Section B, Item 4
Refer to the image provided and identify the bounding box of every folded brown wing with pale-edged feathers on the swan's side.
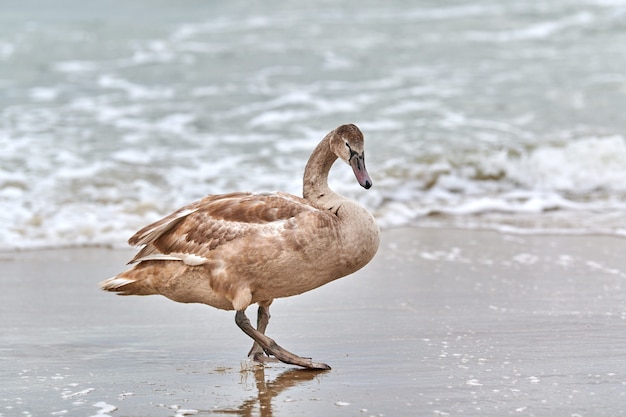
[128,192,336,265]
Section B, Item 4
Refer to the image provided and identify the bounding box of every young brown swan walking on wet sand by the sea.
[100,124,379,369]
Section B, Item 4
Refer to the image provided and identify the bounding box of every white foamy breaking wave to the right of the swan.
[368,135,626,234]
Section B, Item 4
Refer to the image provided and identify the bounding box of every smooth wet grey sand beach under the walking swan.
[0,229,626,417]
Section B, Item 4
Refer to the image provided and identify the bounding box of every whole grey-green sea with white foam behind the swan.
[0,0,626,250]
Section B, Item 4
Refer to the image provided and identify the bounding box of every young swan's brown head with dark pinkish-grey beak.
[330,124,372,189]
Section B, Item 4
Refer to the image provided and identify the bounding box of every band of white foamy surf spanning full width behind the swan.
[0,133,626,250]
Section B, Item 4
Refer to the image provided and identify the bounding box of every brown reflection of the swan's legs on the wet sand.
[212,365,328,417]
